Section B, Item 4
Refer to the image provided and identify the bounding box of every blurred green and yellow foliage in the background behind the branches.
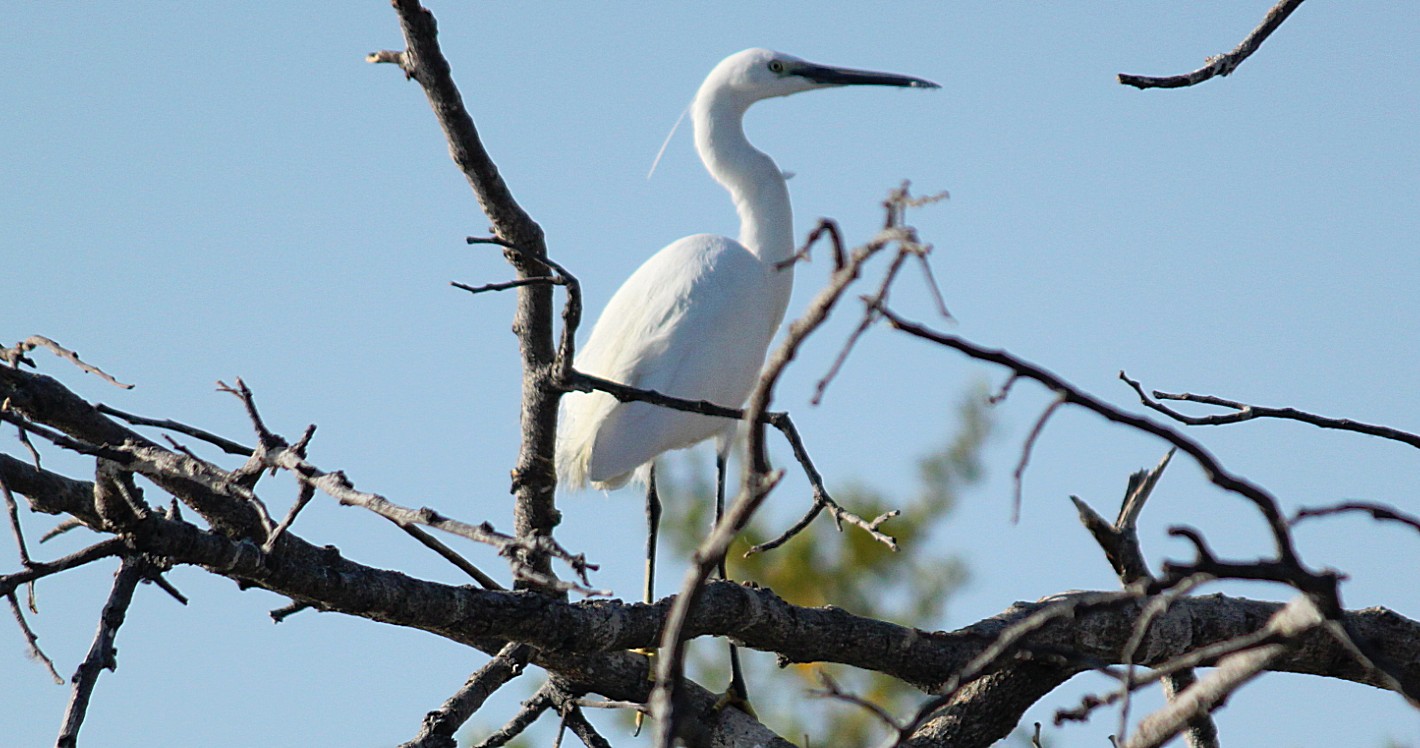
[657,392,991,745]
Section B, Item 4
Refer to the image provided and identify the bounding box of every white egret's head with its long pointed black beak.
[699,48,940,106]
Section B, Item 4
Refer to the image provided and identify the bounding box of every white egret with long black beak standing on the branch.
[557,50,937,704]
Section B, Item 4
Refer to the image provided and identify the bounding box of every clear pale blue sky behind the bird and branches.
[0,1,1420,748]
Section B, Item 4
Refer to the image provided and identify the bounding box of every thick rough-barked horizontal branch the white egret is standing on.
[0,451,1420,748]
